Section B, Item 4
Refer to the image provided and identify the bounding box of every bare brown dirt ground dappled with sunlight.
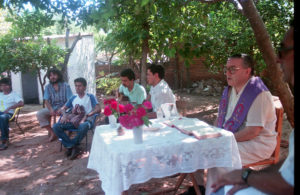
[0,93,291,195]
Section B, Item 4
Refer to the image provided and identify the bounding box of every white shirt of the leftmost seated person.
[0,91,23,114]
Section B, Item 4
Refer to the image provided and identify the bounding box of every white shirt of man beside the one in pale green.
[149,79,176,112]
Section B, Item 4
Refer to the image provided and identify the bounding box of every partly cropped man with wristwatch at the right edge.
[212,18,295,195]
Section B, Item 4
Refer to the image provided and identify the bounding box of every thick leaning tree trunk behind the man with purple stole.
[239,0,294,127]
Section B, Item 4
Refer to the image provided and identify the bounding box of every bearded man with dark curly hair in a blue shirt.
[36,68,73,142]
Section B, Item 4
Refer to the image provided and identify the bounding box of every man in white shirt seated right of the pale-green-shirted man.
[147,64,176,118]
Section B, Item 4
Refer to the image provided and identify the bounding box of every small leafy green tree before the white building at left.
[0,11,65,102]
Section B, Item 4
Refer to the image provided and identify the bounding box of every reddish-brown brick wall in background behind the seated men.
[96,58,226,89]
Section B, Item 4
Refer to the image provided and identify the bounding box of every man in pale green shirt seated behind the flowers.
[118,69,147,105]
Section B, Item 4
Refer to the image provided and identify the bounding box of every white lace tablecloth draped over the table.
[87,118,241,195]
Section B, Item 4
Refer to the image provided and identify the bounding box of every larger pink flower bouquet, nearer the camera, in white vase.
[119,101,152,129]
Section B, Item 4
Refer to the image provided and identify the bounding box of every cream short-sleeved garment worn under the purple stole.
[225,77,277,165]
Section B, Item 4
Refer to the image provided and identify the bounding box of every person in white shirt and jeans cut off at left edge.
[0,78,24,150]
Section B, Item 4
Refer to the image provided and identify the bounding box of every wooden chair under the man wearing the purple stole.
[243,96,283,168]
